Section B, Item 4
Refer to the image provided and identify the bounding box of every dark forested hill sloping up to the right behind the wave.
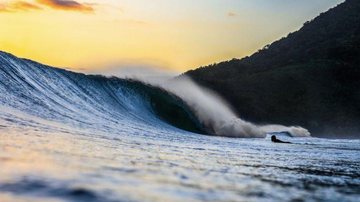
[185,0,360,138]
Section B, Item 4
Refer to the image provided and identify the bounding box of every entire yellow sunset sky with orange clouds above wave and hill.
[0,0,344,72]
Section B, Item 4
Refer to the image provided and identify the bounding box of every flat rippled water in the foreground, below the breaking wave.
[0,127,360,201]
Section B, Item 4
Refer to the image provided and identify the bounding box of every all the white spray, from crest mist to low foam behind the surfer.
[116,69,310,138]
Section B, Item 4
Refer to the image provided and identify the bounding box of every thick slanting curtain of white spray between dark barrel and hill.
[161,77,266,137]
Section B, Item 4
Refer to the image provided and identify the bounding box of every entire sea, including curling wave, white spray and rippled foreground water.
[0,52,360,201]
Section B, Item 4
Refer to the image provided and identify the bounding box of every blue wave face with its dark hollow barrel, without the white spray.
[0,53,205,136]
